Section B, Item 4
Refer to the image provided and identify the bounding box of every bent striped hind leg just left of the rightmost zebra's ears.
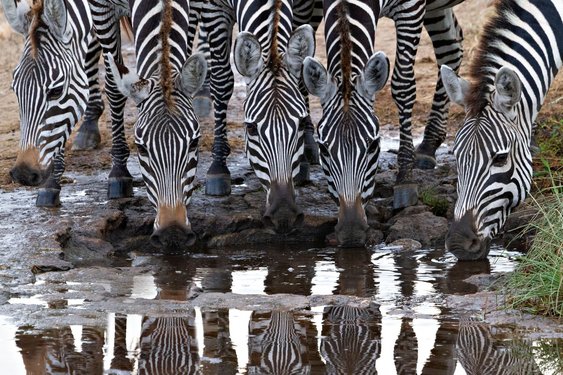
[415,8,463,169]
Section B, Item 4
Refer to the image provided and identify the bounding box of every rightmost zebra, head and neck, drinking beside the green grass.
[441,0,563,260]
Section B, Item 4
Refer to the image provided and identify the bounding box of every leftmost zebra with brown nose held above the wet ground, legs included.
[2,0,132,207]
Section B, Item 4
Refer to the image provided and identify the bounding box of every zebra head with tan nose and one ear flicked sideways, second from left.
[107,53,207,250]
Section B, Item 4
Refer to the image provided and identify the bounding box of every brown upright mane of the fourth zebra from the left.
[336,0,353,112]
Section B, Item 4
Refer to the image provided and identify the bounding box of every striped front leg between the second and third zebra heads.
[201,8,235,196]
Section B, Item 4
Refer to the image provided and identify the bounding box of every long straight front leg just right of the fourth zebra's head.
[391,0,425,209]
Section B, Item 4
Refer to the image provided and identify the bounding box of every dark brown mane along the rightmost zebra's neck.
[466,0,514,116]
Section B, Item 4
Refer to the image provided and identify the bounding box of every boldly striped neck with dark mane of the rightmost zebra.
[470,0,563,135]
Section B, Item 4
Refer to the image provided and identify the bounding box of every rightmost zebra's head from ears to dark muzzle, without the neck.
[441,66,532,260]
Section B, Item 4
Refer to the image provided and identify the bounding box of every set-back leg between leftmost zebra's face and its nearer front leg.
[72,38,104,150]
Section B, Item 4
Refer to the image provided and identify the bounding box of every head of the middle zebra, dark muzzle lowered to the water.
[234,25,315,233]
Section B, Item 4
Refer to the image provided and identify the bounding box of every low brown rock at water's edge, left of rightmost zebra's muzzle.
[385,210,448,247]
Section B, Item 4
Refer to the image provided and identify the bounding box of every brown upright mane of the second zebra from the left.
[160,0,174,108]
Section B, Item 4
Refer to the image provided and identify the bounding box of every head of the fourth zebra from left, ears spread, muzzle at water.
[303,52,389,246]
